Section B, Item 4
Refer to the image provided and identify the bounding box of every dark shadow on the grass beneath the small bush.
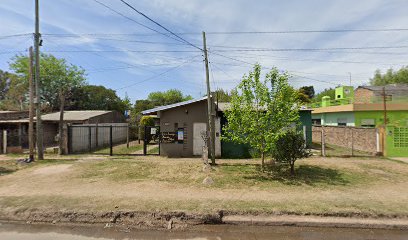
[245,165,350,186]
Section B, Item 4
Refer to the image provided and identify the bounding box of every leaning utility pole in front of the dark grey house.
[203,32,215,164]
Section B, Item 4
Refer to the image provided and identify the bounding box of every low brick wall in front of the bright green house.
[312,126,377,154]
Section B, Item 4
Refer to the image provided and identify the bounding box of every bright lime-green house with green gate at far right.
[311,84,408,157]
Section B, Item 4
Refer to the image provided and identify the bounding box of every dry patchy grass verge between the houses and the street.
[0,155,408,217]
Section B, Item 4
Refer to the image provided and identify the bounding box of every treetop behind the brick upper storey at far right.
[370,66,408,86]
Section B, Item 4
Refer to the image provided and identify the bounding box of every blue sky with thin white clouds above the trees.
[0,0,408,101]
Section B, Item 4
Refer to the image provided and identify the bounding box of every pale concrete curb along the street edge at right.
[222,215,408,230]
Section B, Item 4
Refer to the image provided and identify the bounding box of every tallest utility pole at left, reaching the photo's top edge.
[34,0,44,160]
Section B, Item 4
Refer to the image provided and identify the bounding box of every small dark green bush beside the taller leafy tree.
[271,130,310,175]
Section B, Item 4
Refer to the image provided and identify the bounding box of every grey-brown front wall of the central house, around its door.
[158,100,221,157]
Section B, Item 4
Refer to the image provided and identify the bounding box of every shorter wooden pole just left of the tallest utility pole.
[28,47,34,162]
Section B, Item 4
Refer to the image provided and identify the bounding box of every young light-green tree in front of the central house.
[224,64,299,166]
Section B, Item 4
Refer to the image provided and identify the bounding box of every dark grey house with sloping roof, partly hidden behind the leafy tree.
[142,97,312,158]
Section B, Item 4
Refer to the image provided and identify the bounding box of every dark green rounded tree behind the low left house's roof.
[70,85,129,113]
